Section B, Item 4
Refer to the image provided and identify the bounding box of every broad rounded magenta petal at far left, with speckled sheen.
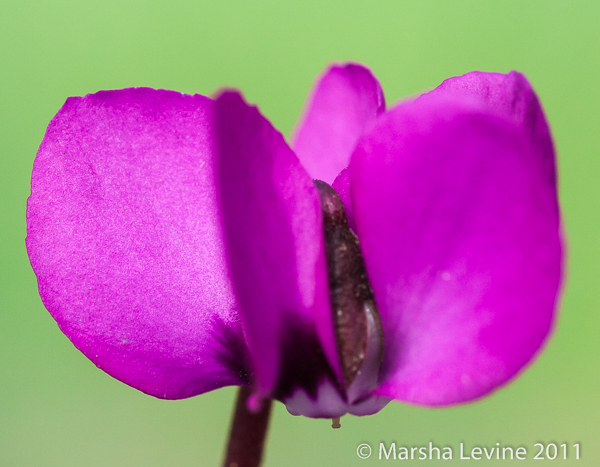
[27,88,249,399]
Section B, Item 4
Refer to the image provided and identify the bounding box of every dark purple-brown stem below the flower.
[223,386,273,467]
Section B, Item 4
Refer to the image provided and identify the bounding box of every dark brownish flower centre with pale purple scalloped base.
[280,180,389,420]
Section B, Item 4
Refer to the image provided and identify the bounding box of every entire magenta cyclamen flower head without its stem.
[27,64,562,417]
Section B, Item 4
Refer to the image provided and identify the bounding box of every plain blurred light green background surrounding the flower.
[0,0,600,466]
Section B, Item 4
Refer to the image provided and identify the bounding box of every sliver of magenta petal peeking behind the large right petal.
[423,71,556,187]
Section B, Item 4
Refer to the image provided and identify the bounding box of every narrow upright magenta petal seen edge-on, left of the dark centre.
[216,91,341,399]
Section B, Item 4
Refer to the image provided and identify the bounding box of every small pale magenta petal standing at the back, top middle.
[292,63,385,185]
